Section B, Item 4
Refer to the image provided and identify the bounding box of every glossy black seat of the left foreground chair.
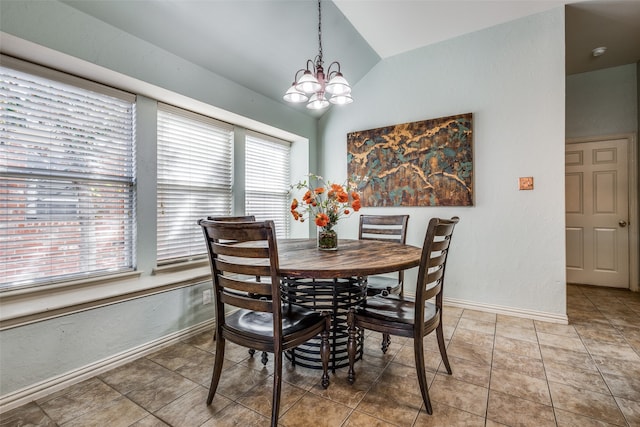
[225,305,323,338]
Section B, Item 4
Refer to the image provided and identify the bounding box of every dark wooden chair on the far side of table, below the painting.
[358,215,409,296]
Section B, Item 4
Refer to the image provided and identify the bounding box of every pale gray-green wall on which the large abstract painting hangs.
[320,8,566,320]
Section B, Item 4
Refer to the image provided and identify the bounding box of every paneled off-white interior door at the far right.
[565,139,629,288]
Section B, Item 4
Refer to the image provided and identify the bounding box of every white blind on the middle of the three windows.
[157,104,233,264]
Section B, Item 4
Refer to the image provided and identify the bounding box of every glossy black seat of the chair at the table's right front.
[356,295,436,325]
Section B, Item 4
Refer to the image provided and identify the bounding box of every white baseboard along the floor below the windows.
[0,319,215,414]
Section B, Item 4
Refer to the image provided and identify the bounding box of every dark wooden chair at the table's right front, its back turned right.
[347,216,459,414]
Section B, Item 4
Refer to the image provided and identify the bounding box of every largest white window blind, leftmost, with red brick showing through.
[0,56,135,289]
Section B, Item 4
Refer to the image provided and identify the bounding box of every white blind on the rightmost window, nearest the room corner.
[245,133,291,238]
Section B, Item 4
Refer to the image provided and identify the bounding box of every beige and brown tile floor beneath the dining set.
[0,286,640,427]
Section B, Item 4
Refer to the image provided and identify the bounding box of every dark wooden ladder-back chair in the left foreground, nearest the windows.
[198,219,330,426]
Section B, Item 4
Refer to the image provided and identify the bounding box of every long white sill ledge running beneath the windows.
[0,263,211,330]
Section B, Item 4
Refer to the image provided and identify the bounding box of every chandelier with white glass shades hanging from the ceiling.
[283,0,353,110]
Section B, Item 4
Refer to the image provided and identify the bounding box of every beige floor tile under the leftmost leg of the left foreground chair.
[154,387,233,427]
